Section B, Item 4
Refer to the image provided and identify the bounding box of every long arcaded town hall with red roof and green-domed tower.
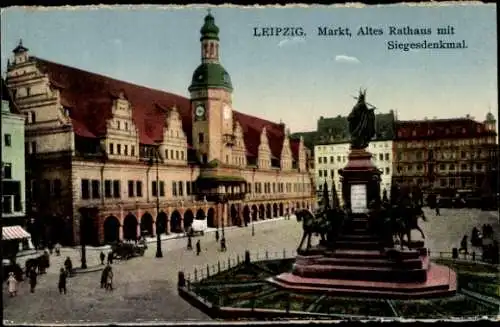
[6,14,315,244]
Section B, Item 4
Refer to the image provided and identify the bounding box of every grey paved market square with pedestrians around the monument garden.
[3,209,500,323]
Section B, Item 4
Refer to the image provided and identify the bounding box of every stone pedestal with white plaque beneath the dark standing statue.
[339,149,381,213]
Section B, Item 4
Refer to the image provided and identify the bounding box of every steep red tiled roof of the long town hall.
[33,57,298,159]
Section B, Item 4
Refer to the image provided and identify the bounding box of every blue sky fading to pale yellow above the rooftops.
[1,3,498,132]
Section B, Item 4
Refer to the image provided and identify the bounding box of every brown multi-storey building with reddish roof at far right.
[393,113,498,196]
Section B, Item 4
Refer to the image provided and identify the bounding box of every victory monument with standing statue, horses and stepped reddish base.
[268,91,456,299]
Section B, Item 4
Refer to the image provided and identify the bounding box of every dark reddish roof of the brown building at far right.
[396,118,496,139]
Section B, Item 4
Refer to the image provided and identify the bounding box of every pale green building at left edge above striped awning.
[1,79,26,226]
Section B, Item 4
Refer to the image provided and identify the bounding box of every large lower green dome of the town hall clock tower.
[189,63,233,91]
